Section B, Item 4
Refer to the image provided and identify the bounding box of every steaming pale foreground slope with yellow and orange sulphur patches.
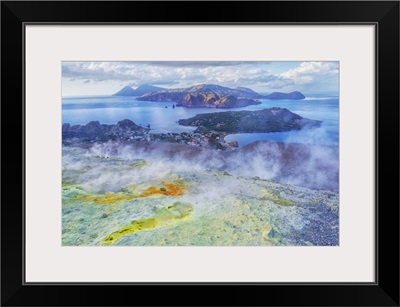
[62,141,339,246]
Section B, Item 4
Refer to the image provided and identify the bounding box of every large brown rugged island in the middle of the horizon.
[137,84,263,108]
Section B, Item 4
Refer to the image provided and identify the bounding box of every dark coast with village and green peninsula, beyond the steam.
[62,107,321,150]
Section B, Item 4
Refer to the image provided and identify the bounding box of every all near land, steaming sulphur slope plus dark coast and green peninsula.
[61,108,339,246]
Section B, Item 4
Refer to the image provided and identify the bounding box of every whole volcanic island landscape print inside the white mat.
[61,61,339,246]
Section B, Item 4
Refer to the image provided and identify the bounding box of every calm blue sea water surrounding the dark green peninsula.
[62,96,339,146]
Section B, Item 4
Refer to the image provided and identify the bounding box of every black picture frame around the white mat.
[1,1,399,306]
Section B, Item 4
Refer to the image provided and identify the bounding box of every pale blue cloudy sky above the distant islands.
[62,61,339,97]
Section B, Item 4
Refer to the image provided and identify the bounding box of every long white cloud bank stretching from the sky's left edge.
[63,62,271,86]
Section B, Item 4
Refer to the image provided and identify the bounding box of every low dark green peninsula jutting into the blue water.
[178,107,321,133]
